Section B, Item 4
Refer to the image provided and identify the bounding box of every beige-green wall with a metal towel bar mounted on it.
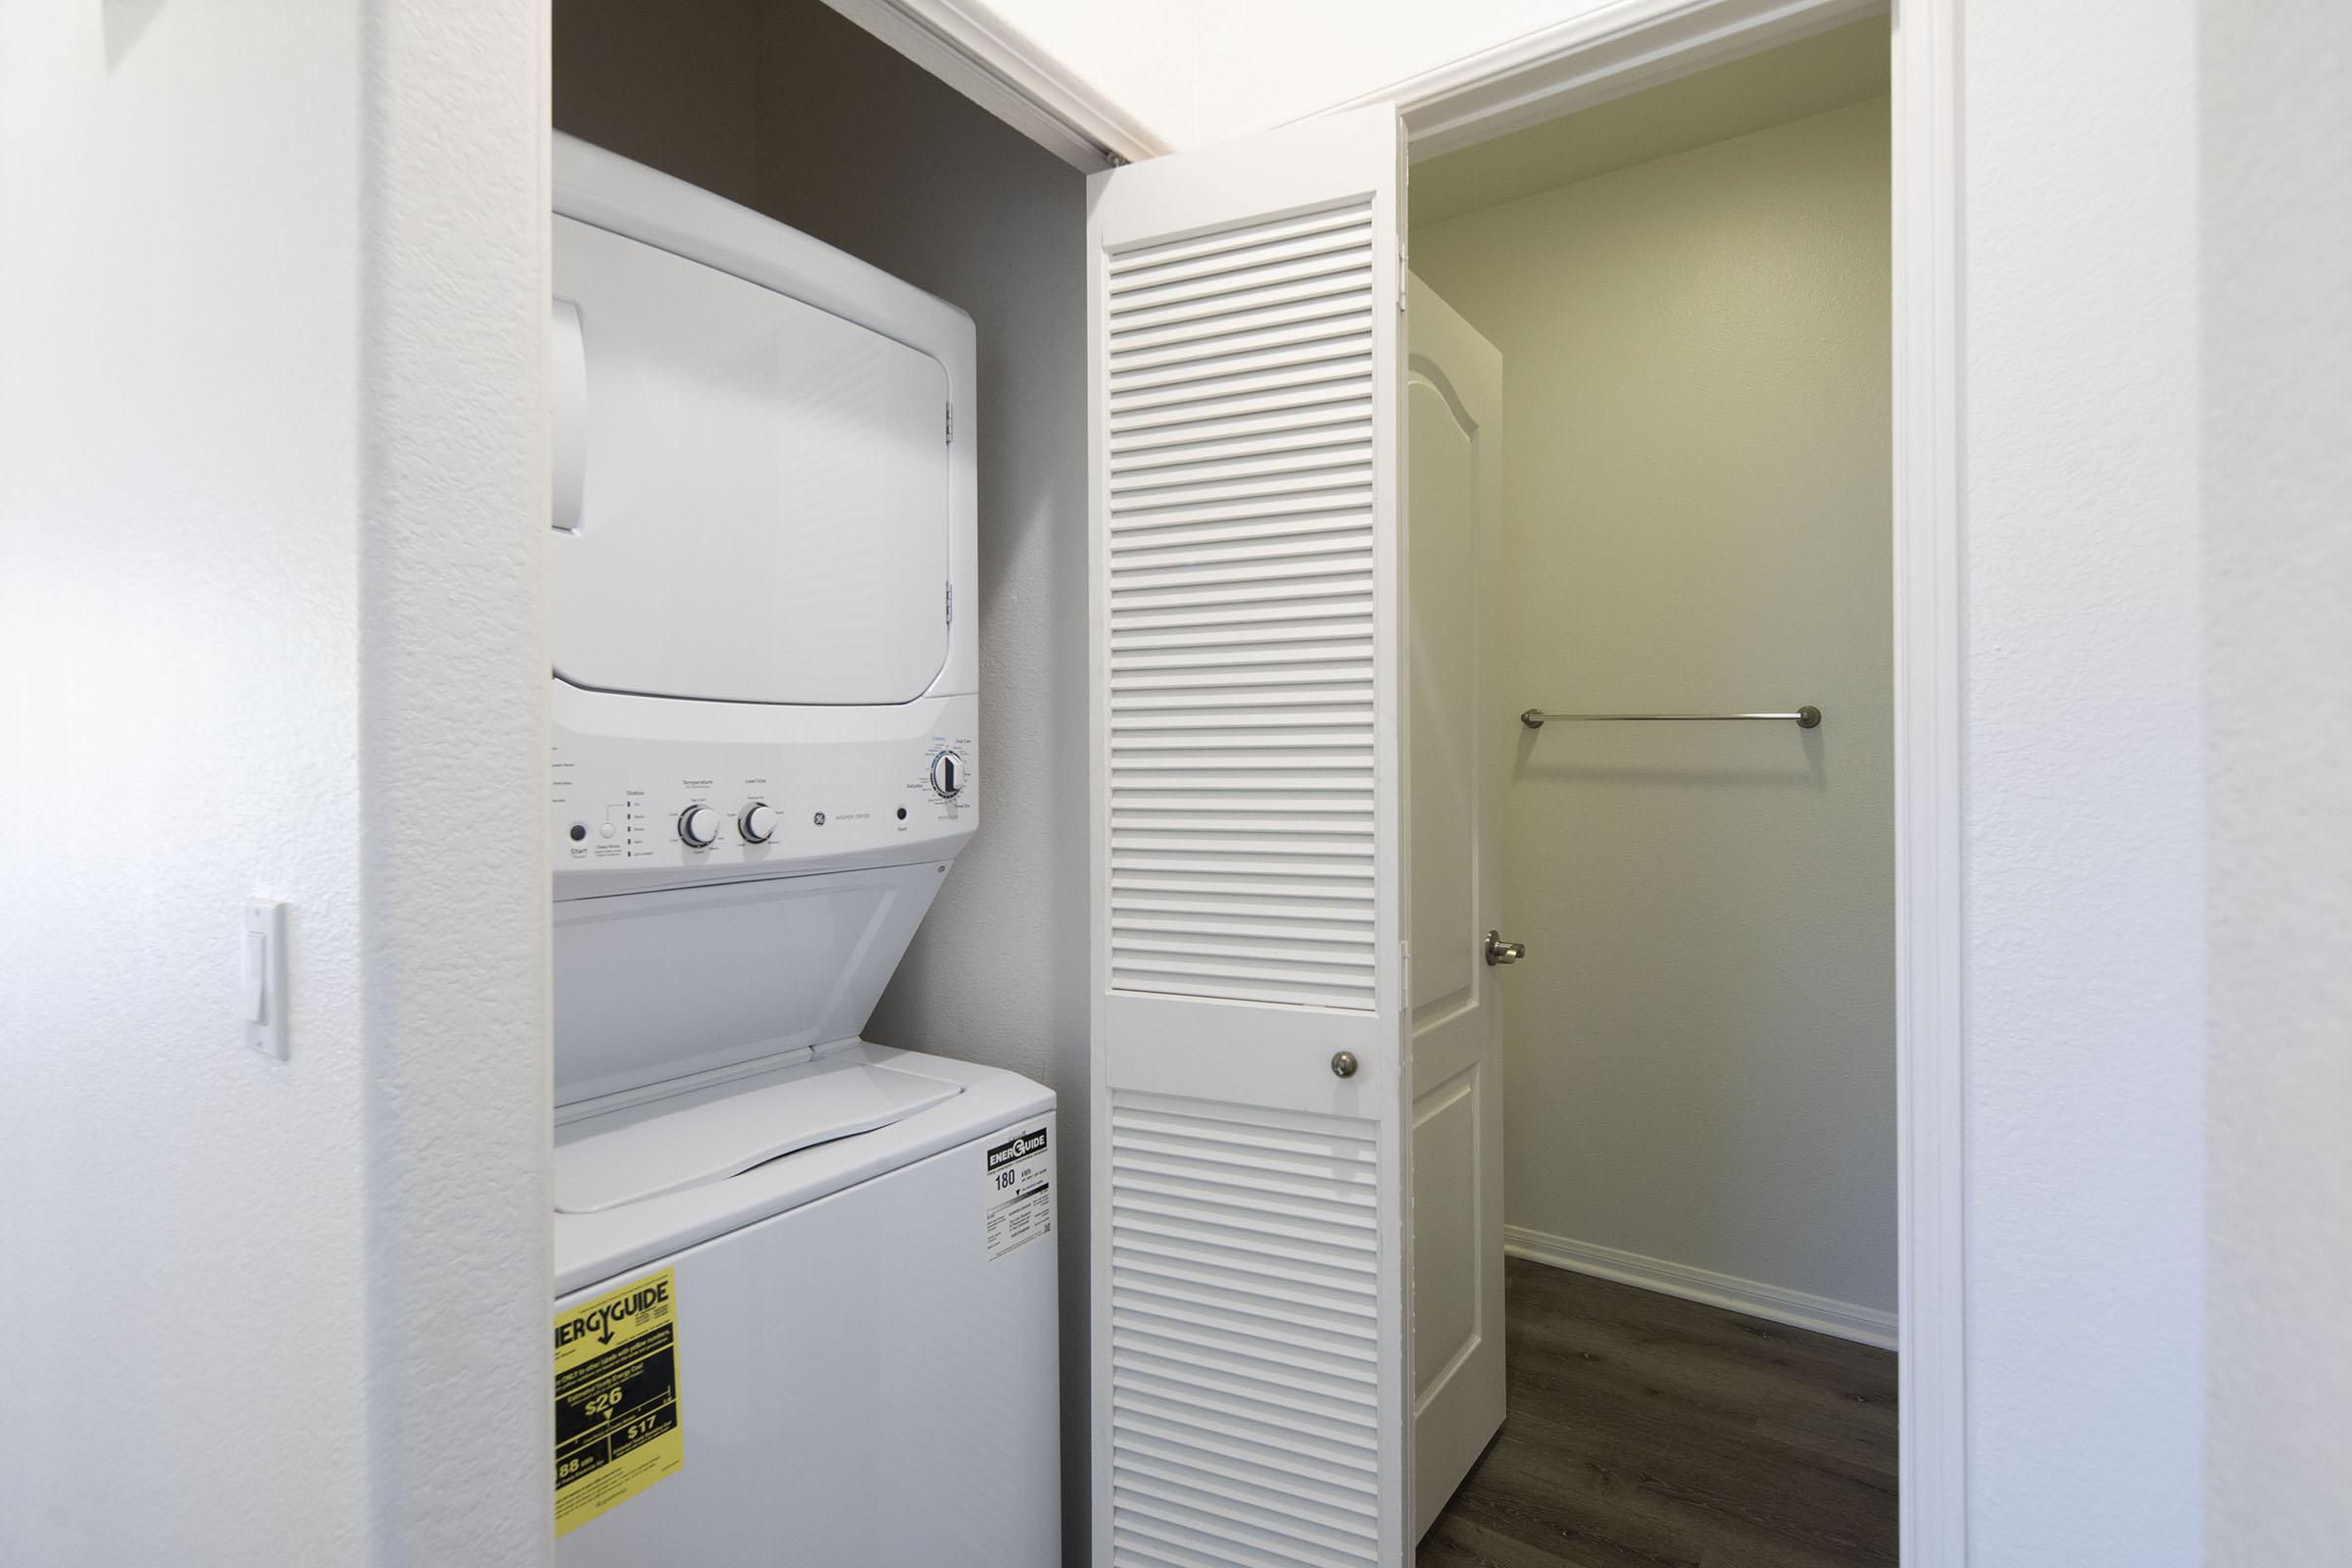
[1413,99,1895,1312]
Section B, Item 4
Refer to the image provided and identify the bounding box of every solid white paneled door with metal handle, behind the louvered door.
[1404,277,1517,1540]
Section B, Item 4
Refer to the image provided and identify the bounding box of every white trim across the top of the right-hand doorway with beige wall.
[1317,0,1886,158]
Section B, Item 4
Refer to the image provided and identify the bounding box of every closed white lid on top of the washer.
[555,1060,962,1213]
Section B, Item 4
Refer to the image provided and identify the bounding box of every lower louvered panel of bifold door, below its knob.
[1105,1091,1381,1568]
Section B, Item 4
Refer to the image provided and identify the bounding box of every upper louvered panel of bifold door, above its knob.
[1105,202,1376,1010]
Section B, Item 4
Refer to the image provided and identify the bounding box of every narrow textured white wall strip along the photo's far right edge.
[2199,0,2352,1568]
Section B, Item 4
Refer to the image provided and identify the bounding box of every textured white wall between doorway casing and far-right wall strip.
[1962,0,2206,1568]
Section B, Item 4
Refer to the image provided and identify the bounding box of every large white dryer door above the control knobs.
[553,217,948,703]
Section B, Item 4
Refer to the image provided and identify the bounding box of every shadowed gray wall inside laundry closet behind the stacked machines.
[555,0,1087,1561]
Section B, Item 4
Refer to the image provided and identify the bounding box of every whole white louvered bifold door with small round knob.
[1089,108,1411,1568]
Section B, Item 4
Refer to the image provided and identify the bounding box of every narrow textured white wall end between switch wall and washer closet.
[360,0,555,1568]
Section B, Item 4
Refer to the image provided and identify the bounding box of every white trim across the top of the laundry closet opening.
[825,0,1169,174]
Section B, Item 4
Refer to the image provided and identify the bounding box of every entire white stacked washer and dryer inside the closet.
[551,136,1060,1568]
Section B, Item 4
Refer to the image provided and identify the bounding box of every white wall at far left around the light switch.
[0,5,369,1566]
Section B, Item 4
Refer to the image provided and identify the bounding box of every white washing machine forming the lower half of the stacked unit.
[555,1044,1060,1568]
